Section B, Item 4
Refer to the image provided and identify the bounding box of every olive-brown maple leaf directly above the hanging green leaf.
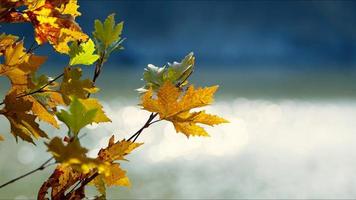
[59,67,99,104]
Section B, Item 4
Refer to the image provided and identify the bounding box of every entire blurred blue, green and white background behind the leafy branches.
[0,0,356,199]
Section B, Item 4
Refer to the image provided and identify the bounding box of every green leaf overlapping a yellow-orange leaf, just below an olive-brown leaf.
[57,98,98,135]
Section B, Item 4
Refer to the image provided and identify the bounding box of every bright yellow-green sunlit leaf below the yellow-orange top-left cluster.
[69,39,99,66]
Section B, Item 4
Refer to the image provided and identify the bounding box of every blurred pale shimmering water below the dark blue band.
[0,68,356,199]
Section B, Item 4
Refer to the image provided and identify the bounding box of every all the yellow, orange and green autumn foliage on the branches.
[0,0,227,199]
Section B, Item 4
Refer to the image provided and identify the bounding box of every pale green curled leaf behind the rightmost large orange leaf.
[137,52,195,93]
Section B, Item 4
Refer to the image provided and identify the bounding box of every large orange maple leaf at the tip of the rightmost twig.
[141,82,228,137]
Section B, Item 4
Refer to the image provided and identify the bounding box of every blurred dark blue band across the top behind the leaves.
[1,0,356,71]
